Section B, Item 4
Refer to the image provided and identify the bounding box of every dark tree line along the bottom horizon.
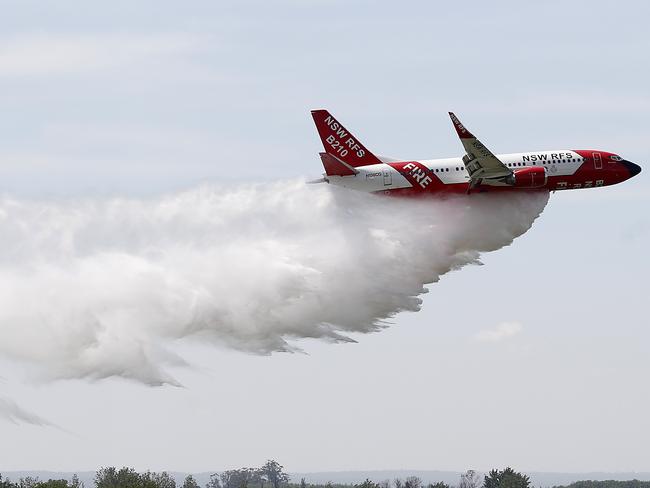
[0,459,650,488]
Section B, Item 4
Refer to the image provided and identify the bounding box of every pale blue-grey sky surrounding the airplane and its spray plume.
[0,1,650,471]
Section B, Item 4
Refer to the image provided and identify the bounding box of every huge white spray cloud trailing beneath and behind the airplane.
[0,182,548,385]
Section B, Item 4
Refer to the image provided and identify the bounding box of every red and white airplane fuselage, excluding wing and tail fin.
[325,149,640,194]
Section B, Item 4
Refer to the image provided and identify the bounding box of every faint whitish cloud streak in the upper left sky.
[0,35,199,76]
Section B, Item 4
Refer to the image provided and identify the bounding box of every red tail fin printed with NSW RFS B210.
[311,110,381,168]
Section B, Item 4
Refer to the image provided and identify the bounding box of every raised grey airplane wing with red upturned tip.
[449,112,512,187]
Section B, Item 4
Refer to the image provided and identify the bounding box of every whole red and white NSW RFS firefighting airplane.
[311,110,641,195]
